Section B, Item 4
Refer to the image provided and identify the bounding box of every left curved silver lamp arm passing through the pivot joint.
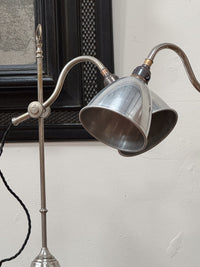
[12,56,112,126]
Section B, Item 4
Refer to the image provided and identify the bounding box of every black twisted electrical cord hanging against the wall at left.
[0,123,31,266]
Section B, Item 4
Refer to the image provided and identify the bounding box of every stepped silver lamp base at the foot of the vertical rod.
[31,248,60,267]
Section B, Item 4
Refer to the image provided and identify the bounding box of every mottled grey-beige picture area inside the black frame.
[0,0,35,65]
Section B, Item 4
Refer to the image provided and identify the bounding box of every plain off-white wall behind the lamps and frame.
[0,0,200,267]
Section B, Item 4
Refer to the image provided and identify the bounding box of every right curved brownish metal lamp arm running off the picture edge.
[144,43,200,92]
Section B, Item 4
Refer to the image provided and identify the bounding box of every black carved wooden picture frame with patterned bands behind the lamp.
[0,0,114,142]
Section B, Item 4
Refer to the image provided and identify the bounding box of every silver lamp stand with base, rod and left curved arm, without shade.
[9,24,121,267]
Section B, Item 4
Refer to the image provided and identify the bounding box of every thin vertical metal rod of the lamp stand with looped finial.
[36,25,47,248]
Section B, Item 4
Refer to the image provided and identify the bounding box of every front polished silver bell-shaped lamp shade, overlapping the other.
[80,77,152,153]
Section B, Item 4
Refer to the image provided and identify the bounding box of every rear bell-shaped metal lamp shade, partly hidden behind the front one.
[119,92,178,157]
